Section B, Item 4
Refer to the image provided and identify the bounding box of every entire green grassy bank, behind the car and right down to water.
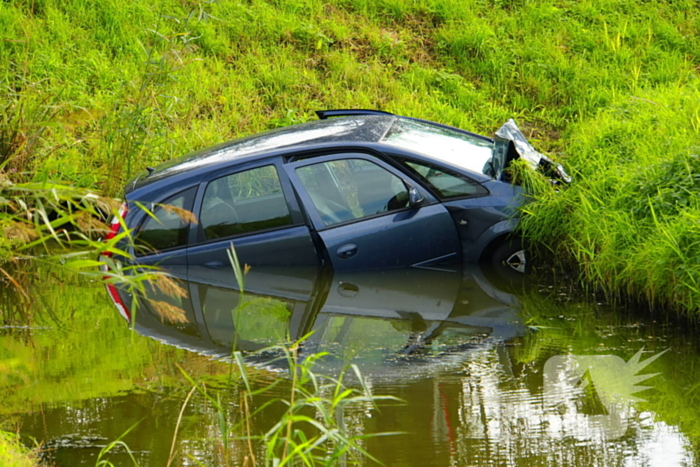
[0,0,700,310]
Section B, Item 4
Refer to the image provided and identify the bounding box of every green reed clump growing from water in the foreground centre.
[159,244,397,467]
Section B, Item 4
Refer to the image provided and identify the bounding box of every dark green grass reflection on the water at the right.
[509,289,700,446]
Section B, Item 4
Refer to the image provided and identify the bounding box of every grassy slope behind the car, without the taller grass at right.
[0,0,700,194]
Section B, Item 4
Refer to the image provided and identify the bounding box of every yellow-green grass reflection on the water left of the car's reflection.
[0,264,227,413]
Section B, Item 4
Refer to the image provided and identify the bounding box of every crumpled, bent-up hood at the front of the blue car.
[490,118,571,183]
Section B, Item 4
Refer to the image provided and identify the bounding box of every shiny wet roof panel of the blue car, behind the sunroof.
[126,114,402,194]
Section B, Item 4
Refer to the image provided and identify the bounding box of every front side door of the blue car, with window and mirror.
[285,153,460,271]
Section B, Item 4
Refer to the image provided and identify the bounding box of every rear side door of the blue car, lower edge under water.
[187,161,319,287]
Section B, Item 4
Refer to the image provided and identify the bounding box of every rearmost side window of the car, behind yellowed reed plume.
[134,188,195,255]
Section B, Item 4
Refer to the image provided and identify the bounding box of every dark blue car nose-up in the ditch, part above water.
[106,110,565,277]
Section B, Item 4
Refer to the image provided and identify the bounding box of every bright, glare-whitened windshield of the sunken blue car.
[382,119,493,173]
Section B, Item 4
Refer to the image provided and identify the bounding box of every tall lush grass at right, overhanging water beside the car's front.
[524,83,700,316]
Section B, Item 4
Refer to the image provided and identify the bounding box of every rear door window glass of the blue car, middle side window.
[200,165,292,240]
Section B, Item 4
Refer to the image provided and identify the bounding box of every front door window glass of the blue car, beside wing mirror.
[296,159,408,226]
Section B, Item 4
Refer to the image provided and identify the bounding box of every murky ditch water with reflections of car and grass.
[0,267,700,466]
